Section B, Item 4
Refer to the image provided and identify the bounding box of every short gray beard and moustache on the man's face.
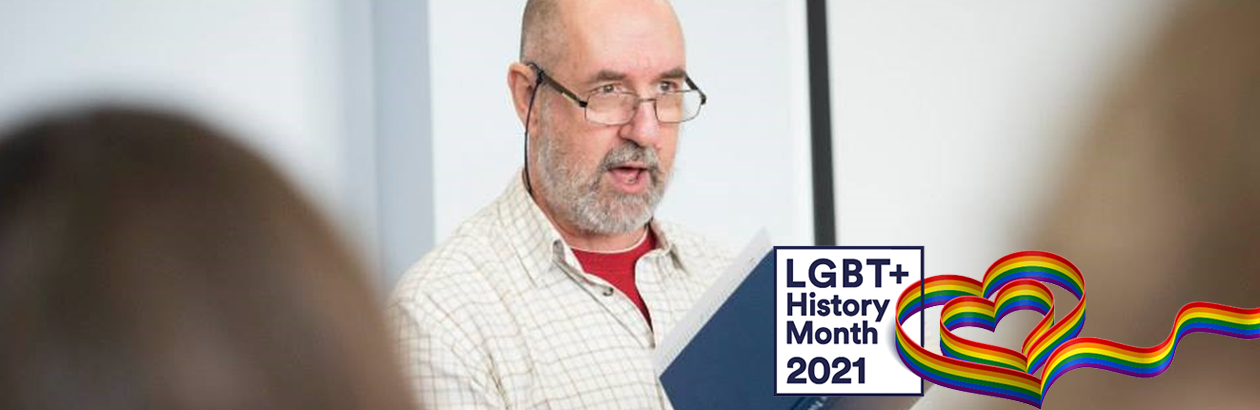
[536,129,669,235]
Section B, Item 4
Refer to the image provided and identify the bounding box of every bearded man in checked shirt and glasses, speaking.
[391,0,728,409]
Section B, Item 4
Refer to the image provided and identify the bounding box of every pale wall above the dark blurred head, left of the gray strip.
[0,0,374,275]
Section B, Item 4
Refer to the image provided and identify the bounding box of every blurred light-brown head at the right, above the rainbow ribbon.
[1038,0,1260,325]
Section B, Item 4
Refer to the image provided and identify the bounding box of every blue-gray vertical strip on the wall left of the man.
[372,0,435,289]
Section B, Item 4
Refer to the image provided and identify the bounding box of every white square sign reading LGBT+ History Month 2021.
[775,249,925,395]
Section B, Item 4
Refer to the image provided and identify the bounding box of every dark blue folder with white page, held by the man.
[654,231,919,410]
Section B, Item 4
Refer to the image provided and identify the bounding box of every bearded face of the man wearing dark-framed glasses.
[533,1,685,235]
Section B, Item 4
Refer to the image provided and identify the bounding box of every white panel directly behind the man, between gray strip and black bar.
[430,0,813,247]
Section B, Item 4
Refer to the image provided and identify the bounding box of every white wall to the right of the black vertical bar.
[828,0,1172,409]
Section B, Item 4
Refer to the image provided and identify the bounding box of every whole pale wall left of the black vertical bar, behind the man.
[0,0,813,289]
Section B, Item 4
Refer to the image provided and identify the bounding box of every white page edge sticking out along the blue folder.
[651,228,771,377]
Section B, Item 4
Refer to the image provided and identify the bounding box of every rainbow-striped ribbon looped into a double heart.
[897,251,1260,409]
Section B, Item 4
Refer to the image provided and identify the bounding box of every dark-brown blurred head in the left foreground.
[0,108,410,409]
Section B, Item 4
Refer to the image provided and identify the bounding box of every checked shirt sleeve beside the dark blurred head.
[389,295,505,410]
